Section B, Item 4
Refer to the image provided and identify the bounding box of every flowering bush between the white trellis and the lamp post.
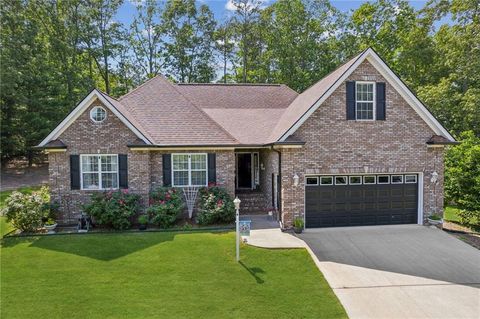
[197,186,235,225]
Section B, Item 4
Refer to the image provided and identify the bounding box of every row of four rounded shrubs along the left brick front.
[3,186,235,232]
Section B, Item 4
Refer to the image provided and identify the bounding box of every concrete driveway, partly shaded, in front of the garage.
[300,225,480,319]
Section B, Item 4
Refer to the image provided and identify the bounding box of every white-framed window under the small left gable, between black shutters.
[80,155,118,190]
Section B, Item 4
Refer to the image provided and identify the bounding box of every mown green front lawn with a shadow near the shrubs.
[1,232,346,319]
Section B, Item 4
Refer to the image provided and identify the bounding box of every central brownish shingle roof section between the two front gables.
[115,76,298,145]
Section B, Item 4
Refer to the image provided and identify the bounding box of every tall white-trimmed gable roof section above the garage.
[270,48,455,141]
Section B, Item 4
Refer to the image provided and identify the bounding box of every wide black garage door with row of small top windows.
[305,174,418,228]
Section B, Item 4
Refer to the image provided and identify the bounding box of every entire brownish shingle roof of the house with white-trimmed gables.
[39,48,455,147]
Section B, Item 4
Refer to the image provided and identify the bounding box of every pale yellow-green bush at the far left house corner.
[2,187,51,232]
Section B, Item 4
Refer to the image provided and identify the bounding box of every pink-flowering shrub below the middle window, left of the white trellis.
[147,187,184,228]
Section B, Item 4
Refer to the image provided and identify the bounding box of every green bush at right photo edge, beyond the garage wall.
[445,131,480,224]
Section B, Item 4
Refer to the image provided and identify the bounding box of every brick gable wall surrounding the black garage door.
[282,61,443,225]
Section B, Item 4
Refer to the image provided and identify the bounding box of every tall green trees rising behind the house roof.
[0,0,480,162]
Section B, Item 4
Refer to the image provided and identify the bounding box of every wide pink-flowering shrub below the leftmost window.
[83,190,140,229]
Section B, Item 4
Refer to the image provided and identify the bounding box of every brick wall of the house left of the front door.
[48,101,235,224]
